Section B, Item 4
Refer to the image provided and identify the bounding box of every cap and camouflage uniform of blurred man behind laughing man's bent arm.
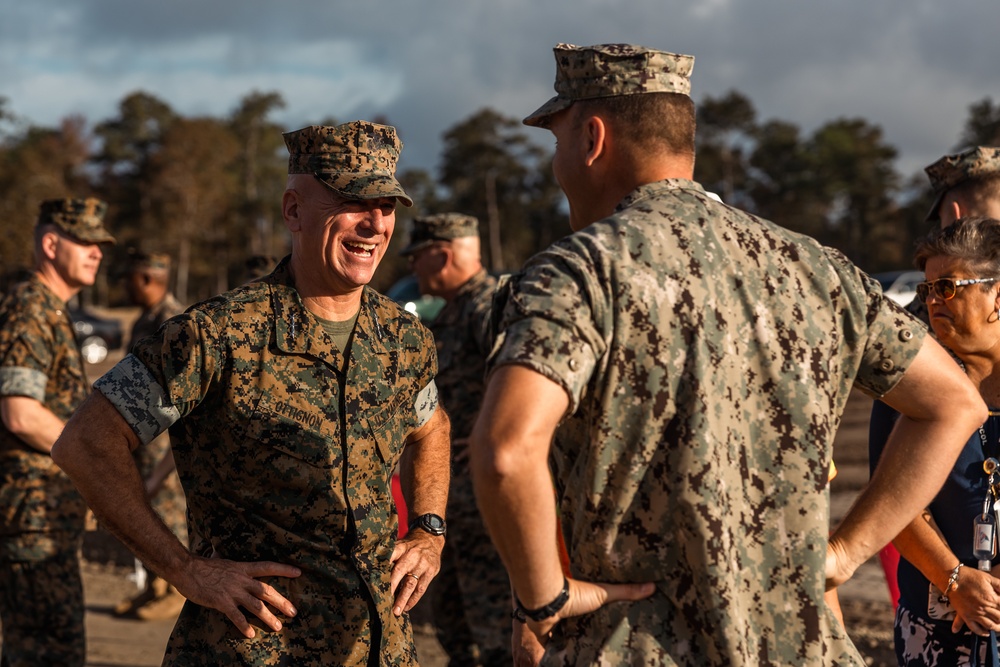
[129,290,187,544]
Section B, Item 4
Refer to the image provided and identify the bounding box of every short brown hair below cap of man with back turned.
[573,93,695,159]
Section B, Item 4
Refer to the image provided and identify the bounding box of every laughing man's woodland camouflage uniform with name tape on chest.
[95,258,437,665]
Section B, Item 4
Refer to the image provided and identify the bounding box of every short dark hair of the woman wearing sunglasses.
[914,218,1000,291]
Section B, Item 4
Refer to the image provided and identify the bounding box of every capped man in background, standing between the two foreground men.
[400,213,513,667]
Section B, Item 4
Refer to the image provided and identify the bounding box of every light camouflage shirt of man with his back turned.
[490,179,925,667]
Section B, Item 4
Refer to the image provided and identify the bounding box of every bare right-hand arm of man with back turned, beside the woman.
[827,337,987,588]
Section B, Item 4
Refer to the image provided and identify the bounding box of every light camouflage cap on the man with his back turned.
[524,44,694,127]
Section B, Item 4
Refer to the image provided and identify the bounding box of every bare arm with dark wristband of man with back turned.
[470,365,654,637]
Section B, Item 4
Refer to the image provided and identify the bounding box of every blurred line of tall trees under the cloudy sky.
[0,91,1000,305]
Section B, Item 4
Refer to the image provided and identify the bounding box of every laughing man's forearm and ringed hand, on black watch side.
[391,405,451,616]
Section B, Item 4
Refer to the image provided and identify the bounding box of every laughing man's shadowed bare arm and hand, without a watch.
[52,392,299,638]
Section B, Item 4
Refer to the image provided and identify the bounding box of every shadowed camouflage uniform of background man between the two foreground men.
[430,268,513,667]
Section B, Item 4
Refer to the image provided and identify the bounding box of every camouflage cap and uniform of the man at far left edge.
[0,199,114,667]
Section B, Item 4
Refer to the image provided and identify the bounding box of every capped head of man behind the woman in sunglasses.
[924,146,1000,227]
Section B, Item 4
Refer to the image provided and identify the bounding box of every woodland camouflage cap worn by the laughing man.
[282,120,413,206]
